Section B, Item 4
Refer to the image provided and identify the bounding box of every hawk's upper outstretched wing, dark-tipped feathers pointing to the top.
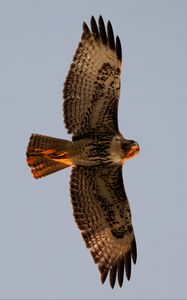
[63,16,122,138]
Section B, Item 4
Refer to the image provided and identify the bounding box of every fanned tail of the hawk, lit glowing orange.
[26,134,72,178]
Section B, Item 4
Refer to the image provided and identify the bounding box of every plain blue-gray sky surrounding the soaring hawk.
[0,0,187,299]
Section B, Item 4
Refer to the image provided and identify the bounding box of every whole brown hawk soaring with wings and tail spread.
[26,16,139,288]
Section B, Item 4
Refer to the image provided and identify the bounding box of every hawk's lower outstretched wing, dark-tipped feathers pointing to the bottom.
[70,164,137,288]
